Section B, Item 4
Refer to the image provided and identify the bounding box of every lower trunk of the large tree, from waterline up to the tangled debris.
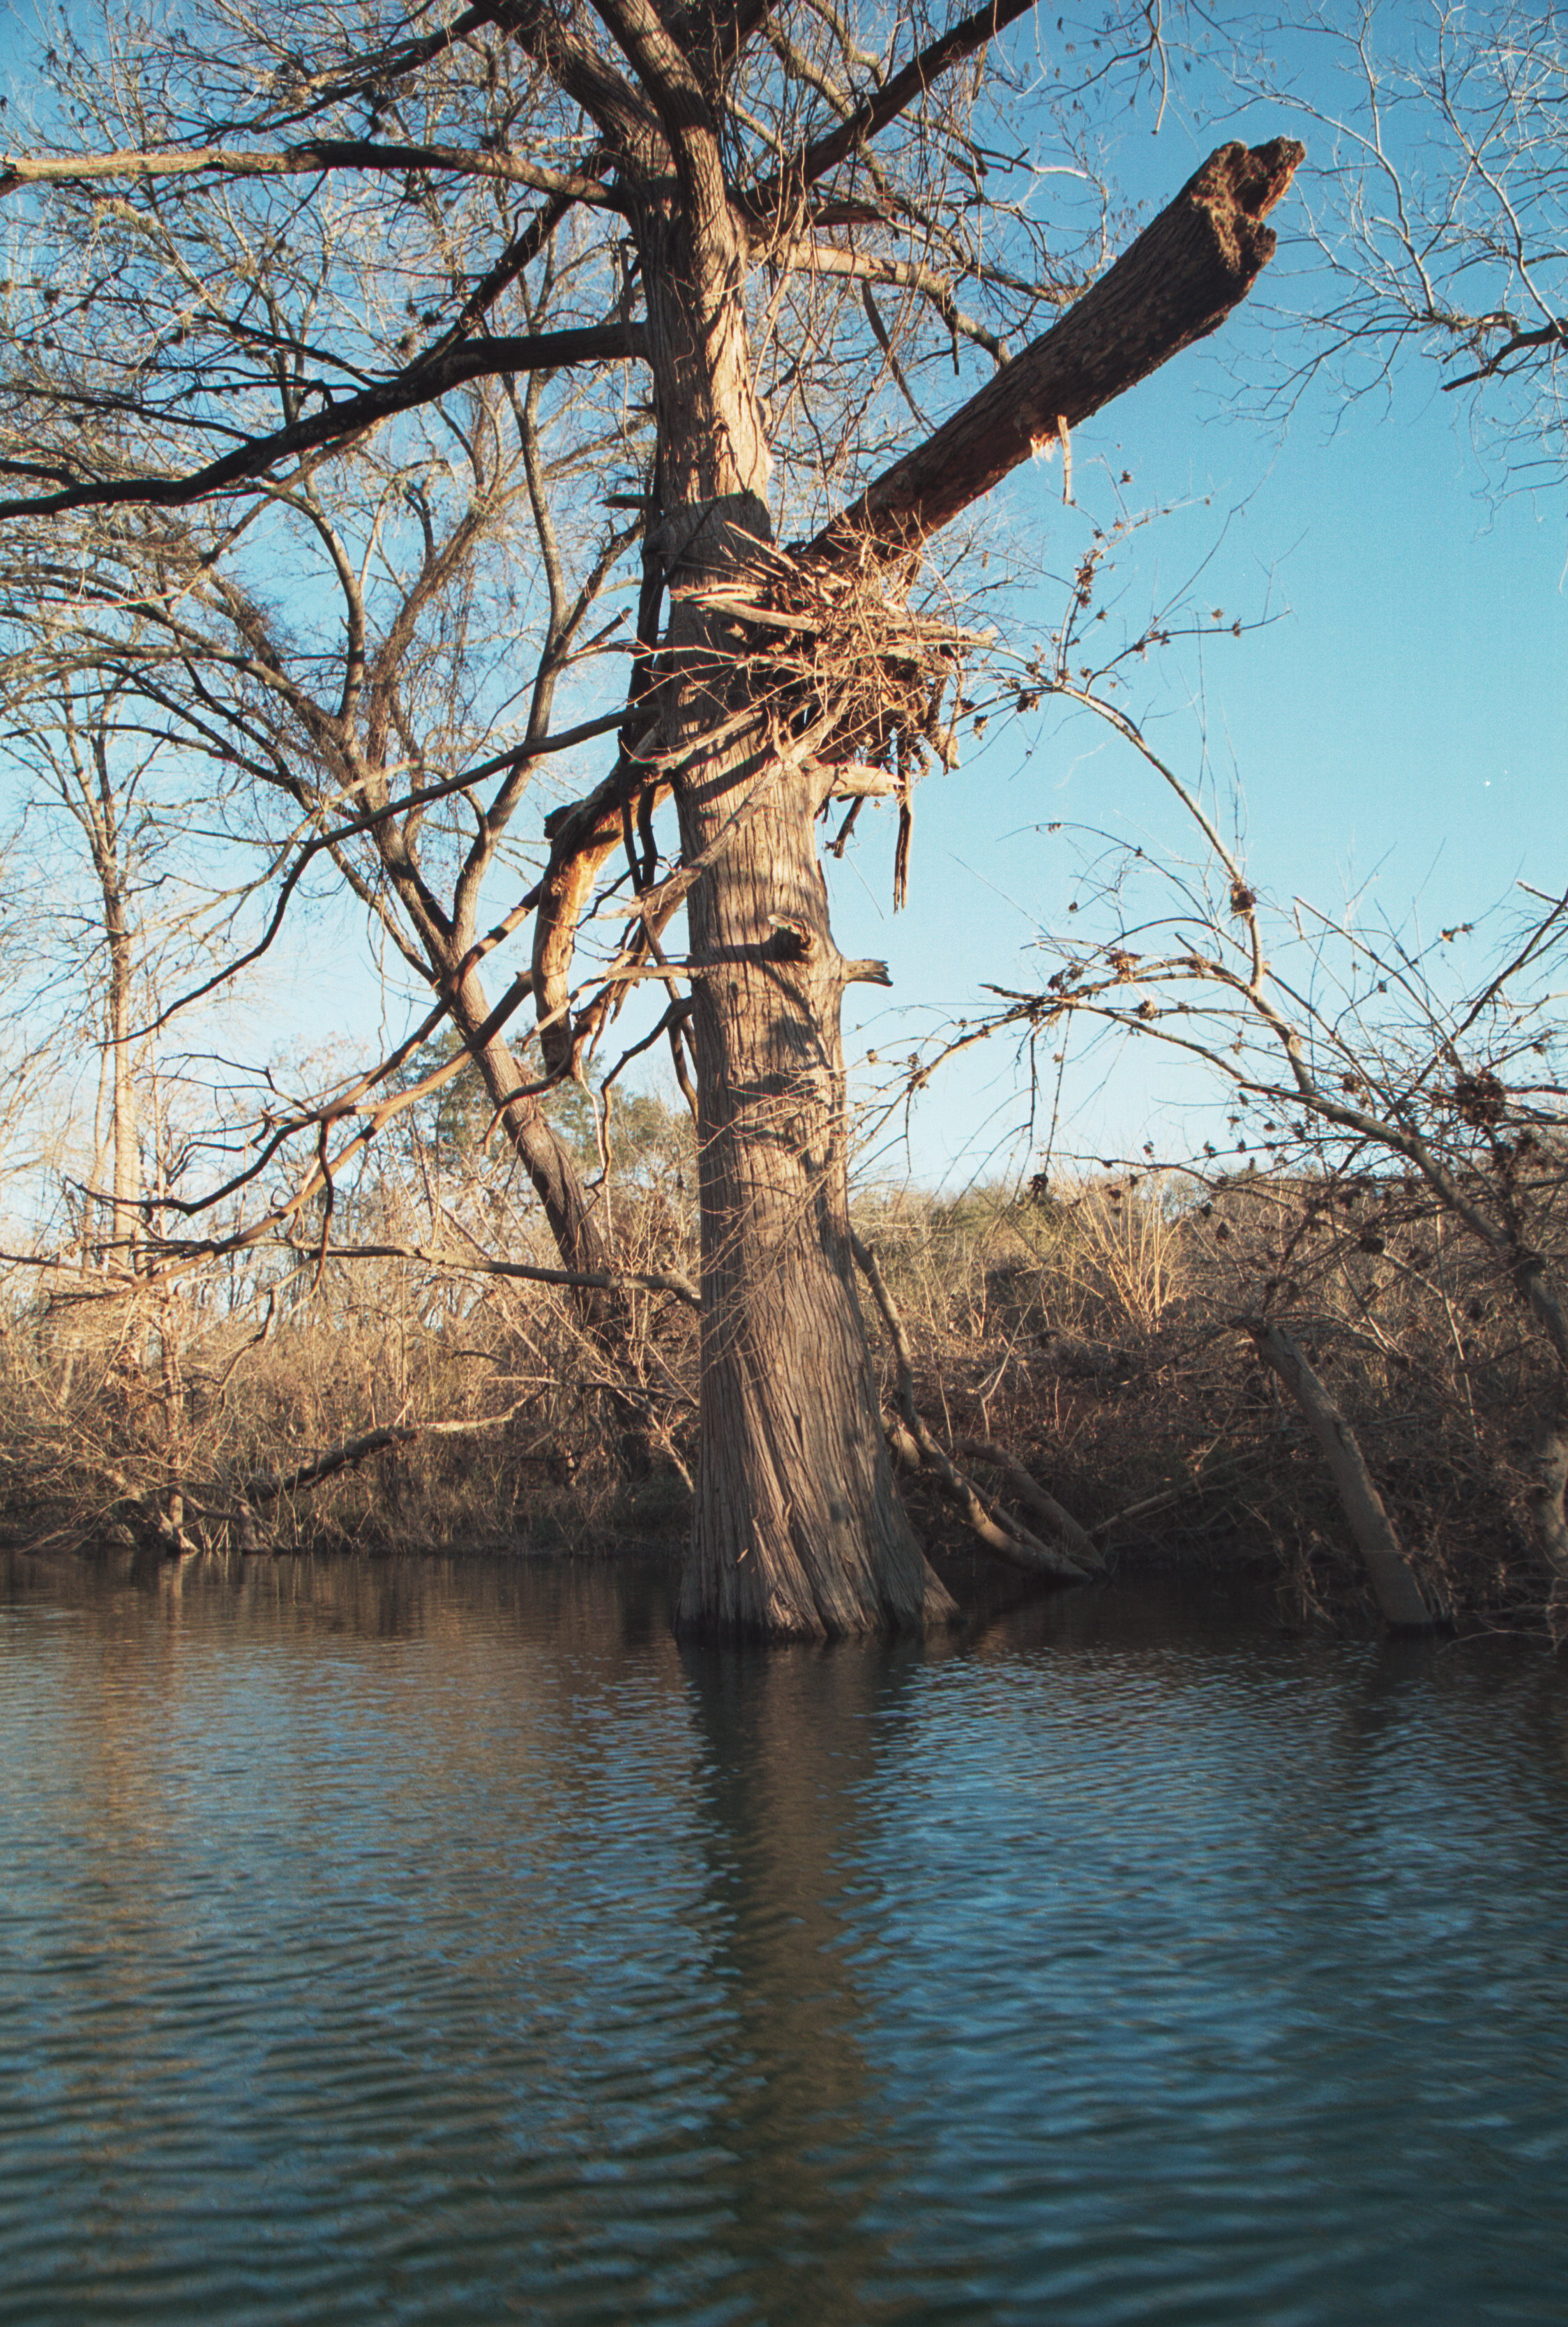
[679,725,951,1639]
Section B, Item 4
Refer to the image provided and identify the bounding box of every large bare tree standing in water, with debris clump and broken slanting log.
[0,0,1300,1636]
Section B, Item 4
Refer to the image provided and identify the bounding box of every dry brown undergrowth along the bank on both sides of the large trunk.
[0,1089,1552,1627]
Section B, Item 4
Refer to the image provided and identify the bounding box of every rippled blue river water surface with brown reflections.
[0,1561,1568,2327]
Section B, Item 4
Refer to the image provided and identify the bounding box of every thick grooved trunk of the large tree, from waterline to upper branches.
[640,212,953,1639]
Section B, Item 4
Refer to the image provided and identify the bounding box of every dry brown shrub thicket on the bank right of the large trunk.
[866,1170,1552,1625]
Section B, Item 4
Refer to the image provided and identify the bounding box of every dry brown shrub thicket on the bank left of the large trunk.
[0,1110,695,1552]
